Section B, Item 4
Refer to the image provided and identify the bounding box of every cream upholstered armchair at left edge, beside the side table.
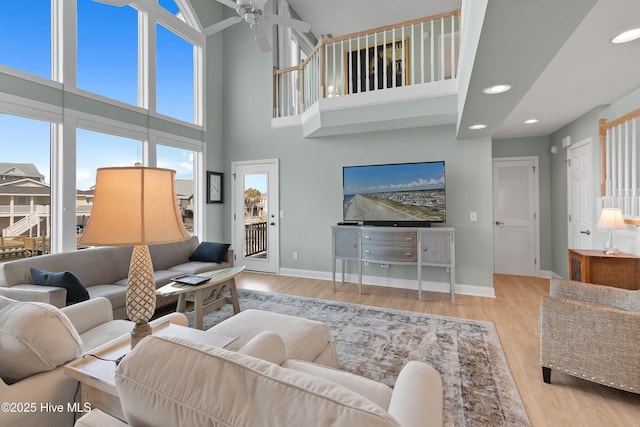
[0,296,187,427]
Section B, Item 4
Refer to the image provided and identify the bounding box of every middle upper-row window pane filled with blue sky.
[77,0,138,105]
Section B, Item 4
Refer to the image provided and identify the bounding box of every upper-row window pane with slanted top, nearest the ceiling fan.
[156,24,195,123]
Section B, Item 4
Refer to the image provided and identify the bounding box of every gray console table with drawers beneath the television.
[331,225,456,304]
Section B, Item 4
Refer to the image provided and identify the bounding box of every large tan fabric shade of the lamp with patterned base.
[79,166,190,246]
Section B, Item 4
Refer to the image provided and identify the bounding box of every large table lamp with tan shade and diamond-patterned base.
[79,166,190,348]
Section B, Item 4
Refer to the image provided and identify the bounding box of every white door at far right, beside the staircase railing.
[567,138,593,249]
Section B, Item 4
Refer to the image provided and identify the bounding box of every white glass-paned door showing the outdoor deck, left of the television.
[231,160,279,273]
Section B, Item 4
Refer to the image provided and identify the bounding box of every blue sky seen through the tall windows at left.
[0,0,193,190]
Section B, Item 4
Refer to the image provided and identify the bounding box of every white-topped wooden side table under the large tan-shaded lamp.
[64,321,238,422]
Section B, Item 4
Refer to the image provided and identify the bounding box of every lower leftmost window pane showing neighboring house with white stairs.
[0,114,51,244]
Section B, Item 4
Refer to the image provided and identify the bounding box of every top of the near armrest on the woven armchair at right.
[549,279,640,312]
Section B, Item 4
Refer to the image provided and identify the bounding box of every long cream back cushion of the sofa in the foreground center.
[116,335,399,427]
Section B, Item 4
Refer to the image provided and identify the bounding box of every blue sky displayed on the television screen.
[343,162,444,194]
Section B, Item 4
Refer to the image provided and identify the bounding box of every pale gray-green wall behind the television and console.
[223,26,493,287]
